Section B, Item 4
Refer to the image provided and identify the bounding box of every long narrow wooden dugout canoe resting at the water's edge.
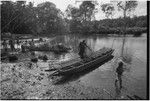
[52,48,114,76]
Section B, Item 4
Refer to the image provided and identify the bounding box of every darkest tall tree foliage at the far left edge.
[1,1,36,34]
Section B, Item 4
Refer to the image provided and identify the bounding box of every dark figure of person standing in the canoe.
[79,40,91,59]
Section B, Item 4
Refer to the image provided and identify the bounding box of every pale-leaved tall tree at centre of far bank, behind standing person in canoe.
[66,1,97,33]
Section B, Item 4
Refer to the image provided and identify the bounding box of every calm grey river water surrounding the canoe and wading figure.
[33,35,147,99]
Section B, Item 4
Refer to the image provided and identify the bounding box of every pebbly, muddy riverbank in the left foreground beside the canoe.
[0,55,102,99]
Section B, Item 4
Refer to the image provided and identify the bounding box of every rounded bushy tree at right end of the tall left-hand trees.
[37,2,66,33]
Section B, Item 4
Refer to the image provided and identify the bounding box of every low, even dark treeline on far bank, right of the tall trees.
[71,16,147,35]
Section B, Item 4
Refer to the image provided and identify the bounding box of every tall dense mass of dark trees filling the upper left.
[1,1,66,34]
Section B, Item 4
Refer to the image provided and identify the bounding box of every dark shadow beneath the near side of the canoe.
[52,56,114,85]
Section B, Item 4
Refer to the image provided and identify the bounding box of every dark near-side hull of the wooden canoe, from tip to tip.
[53,50,114,75]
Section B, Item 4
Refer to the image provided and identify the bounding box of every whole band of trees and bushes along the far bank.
[0,1,147,35]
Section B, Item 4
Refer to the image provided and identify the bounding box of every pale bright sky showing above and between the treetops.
[7,0,147,20]
